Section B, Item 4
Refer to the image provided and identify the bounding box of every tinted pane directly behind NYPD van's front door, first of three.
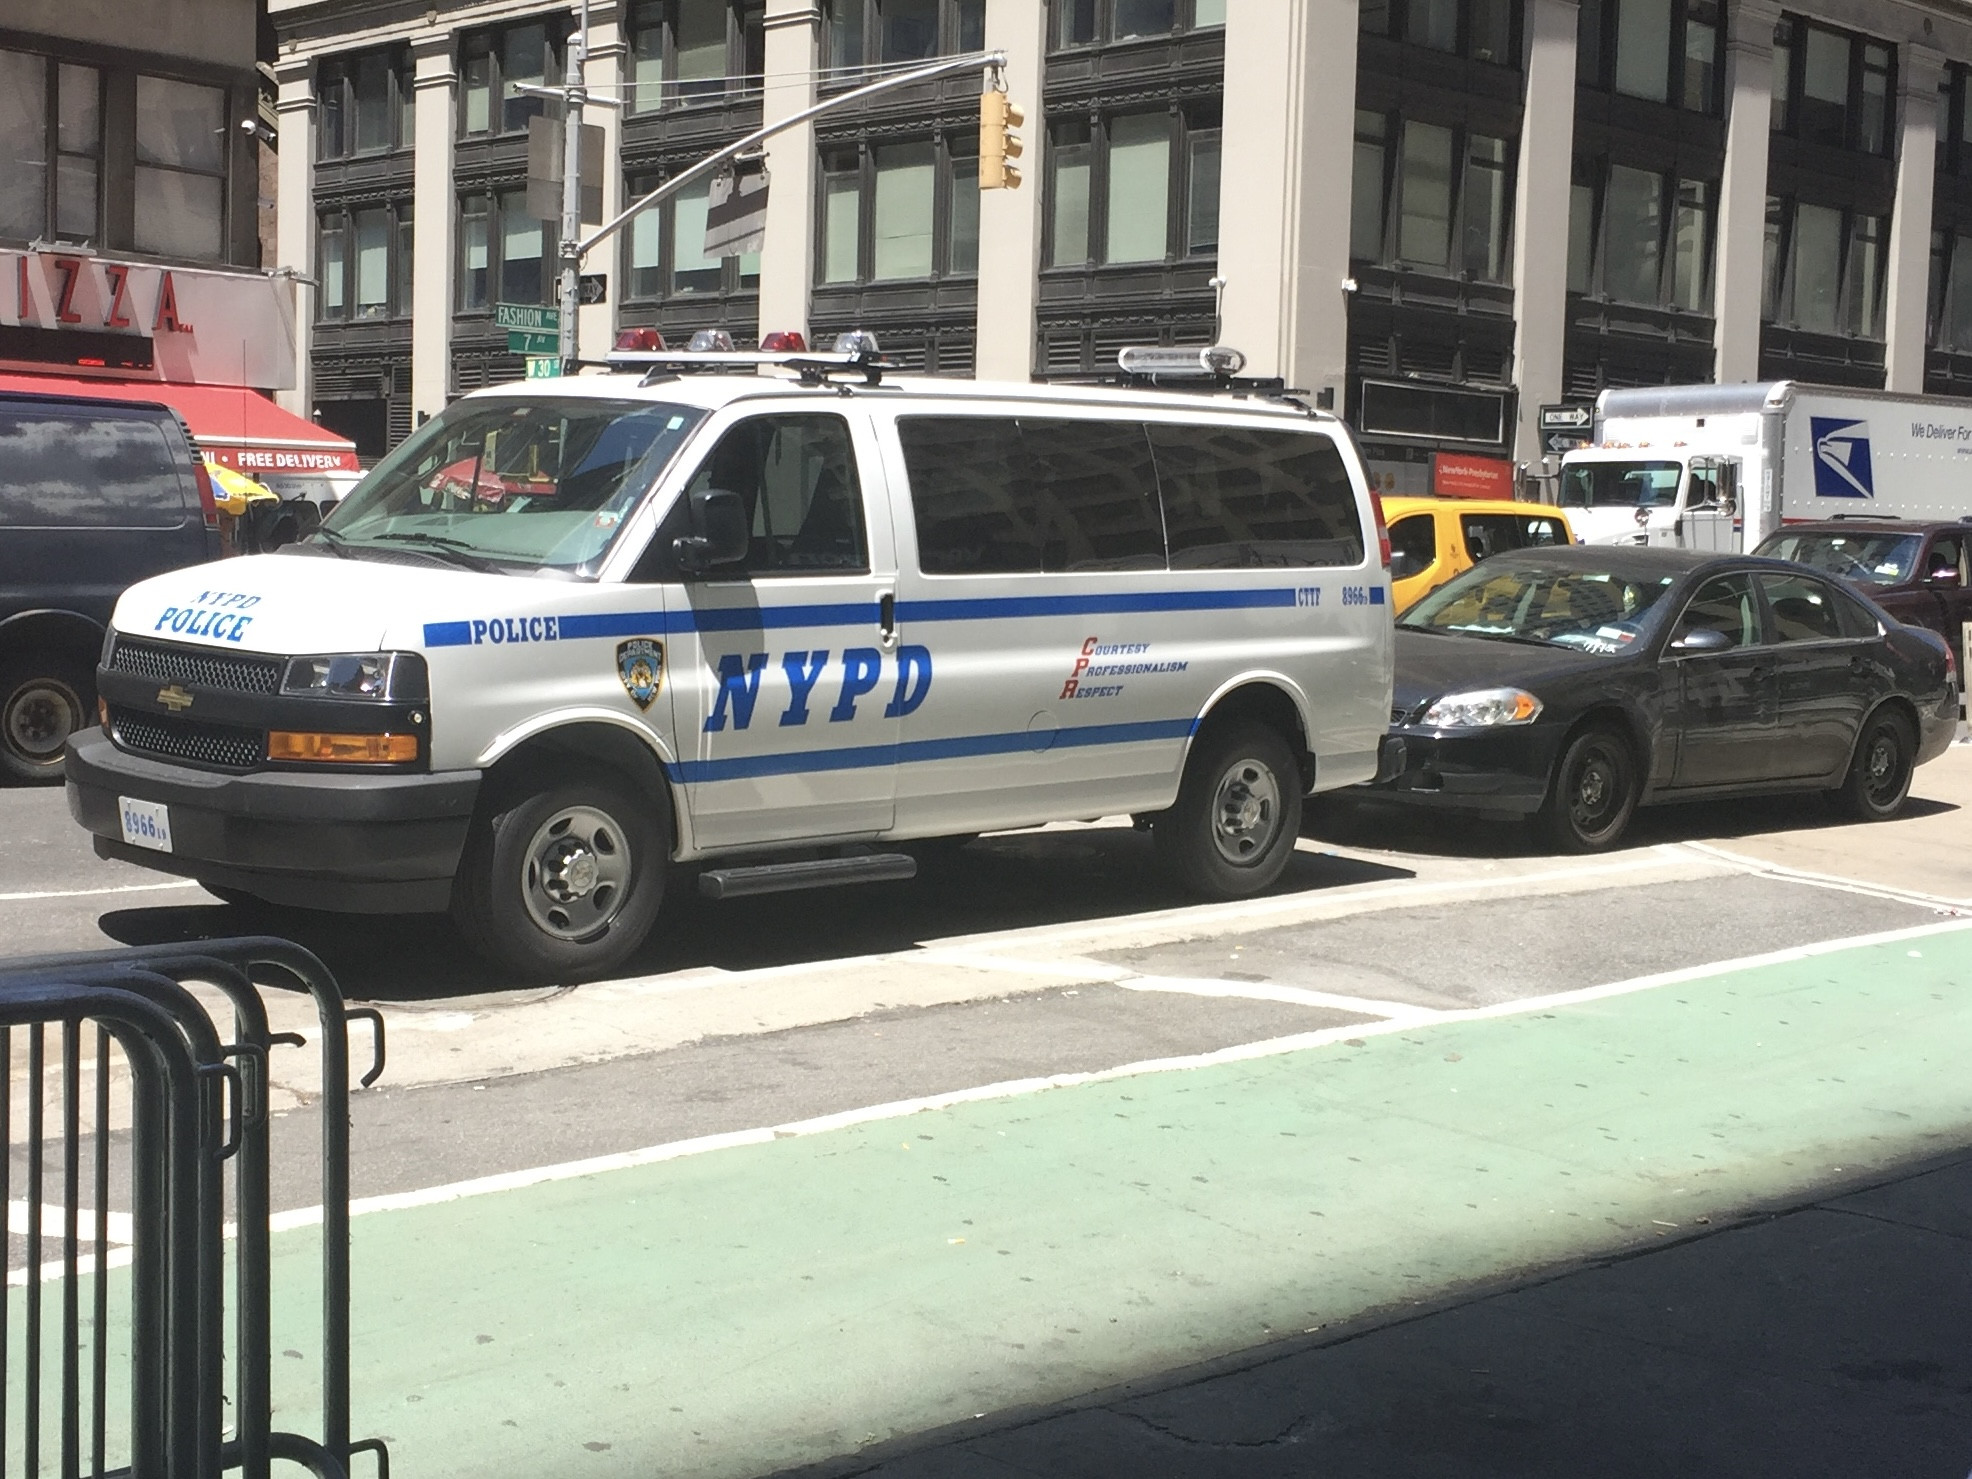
[897,416,1053,576]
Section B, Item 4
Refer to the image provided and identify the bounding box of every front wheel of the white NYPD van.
[452,771,670,982]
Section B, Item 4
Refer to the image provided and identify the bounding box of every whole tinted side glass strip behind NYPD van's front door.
[897,416,1365,576]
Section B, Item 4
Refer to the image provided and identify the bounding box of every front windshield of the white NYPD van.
[323,398,706,576]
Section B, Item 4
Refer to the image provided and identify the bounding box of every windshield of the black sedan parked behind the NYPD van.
[1396,564,1672,657]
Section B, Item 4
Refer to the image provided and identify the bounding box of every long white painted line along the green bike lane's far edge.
[246,919,1972,1233]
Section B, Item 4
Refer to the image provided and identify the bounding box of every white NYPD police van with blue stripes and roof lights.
[67,347,1392,980]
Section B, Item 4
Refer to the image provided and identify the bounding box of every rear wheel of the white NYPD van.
[1150,724,1302,899]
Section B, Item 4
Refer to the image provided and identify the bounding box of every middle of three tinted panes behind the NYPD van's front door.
[1020,416,1163,570]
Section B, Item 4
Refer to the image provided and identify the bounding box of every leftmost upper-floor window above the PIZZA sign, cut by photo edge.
[0,51,103,243]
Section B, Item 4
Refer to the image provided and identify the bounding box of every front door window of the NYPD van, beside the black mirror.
[680,414,870,576]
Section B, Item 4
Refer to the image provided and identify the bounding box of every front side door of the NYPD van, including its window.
[659,408,909,850]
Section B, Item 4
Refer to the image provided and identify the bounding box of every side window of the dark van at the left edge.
[0,410,187,528]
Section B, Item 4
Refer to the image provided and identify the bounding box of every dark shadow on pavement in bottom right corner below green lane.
[765,1150,1972,1479]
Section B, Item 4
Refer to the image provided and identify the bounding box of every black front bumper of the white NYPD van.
[65,730,479,913]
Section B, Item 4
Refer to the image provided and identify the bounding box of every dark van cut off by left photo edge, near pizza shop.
[0,392,221,781]
